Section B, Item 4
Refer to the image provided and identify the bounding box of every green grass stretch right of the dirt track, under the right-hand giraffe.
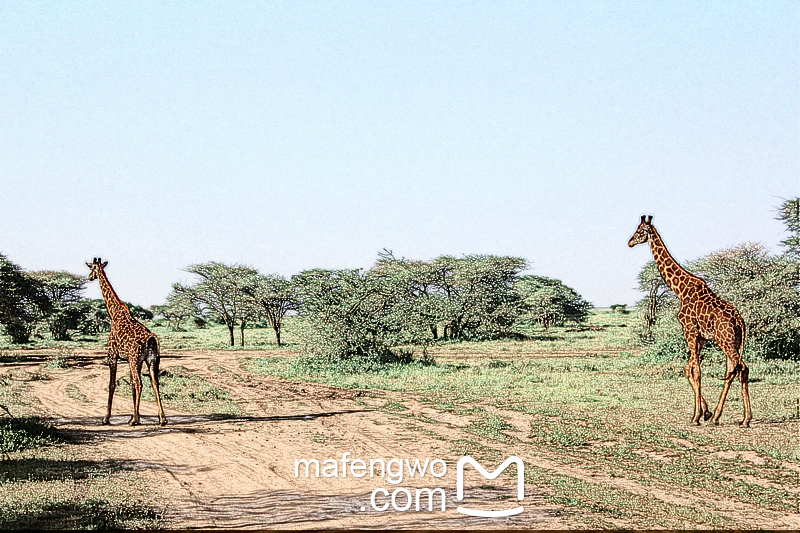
[242,313,800,528]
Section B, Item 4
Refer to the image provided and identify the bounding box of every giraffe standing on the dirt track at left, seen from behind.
[86,257,167,426]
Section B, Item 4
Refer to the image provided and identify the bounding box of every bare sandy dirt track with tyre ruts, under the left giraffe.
[7,351,800,529]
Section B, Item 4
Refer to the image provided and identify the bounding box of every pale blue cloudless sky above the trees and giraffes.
[0,1,800,306]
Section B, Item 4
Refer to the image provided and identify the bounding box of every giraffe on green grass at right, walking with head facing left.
[628,215,753,427]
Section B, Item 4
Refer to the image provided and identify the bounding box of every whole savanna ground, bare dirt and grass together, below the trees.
[0,310,800,529]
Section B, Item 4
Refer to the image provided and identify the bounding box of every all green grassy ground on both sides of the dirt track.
[0,312,800,529]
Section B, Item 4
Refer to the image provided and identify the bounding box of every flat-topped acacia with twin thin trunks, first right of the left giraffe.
[172,261,258,346]
